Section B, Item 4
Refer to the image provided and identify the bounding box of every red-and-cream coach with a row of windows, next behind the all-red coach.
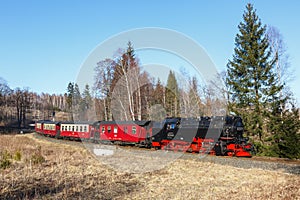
[60,122,93,139]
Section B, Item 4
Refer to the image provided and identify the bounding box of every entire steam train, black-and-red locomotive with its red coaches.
[35,116,254,157]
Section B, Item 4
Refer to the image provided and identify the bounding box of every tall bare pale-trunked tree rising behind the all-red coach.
[111,42,145,120]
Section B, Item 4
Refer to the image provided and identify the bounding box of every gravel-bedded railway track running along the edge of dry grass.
[33,133,300,176]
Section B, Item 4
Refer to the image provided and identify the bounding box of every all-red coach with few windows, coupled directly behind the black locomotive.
[99,121,150,145]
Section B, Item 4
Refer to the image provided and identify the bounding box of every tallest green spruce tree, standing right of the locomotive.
[226,4,283,143]
